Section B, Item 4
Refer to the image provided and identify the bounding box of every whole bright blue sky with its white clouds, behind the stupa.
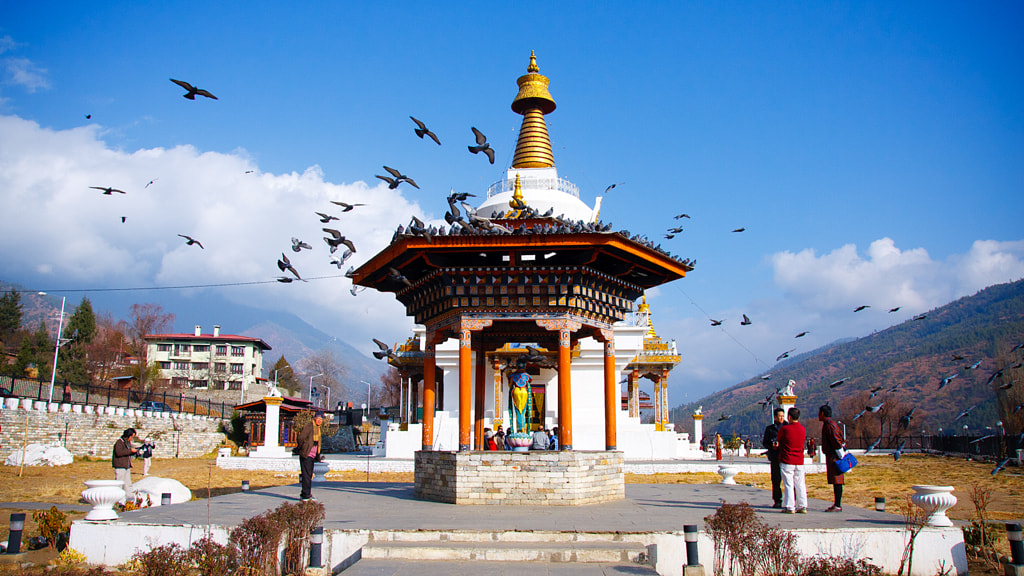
[0,2,1024,404]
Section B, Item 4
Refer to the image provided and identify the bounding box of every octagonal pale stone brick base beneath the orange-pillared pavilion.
[415,451,626,506]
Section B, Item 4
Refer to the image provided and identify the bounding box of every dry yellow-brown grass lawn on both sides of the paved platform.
[0,454,1024,574]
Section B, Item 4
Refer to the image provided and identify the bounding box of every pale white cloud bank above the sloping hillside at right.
[648,233,1024,403]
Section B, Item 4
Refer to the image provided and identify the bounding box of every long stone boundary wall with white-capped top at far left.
[0,400,224,458]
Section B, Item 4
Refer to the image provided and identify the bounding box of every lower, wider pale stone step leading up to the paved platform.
[361,540,648,565]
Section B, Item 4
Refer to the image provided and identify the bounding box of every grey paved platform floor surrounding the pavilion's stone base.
[121,482,903,533]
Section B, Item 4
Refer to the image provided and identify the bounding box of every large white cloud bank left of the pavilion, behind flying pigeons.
[0,116,427,349]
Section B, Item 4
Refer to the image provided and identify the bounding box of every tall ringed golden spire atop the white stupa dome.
[512,50,555,168]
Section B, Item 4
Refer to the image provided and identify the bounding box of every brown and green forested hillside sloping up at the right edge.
[670,281,1024,436]
